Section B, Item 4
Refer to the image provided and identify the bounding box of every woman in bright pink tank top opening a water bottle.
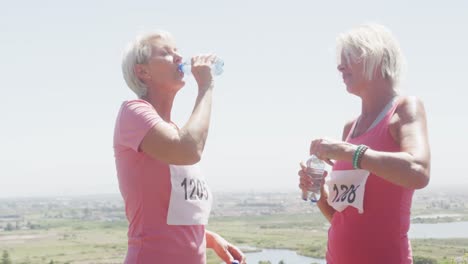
[299,25,430,264]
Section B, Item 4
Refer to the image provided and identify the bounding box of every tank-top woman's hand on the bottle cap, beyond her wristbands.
[310,138,354,166]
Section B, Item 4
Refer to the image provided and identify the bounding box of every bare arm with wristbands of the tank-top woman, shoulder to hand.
[311,97,430,189]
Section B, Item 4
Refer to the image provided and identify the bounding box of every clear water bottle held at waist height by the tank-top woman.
[302,155,325,203]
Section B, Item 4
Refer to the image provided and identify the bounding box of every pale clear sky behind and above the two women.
[0,0,468,197]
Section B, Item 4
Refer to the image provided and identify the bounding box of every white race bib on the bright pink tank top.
[324,170,370,214]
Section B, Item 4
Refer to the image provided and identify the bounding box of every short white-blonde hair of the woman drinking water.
[122,30,171,98]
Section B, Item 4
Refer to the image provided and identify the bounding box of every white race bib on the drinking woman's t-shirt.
[167,165,213,225]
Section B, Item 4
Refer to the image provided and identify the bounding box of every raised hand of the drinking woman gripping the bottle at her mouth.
[192,54,216,91]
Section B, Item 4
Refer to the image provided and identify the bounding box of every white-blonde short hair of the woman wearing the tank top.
[337,24,404,84]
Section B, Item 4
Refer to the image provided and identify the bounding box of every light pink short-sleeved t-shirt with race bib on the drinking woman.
[114,100,211,264]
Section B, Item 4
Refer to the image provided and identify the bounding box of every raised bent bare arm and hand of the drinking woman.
[140,55,218,165]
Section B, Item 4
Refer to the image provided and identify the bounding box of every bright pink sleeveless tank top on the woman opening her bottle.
[326,100,414,264]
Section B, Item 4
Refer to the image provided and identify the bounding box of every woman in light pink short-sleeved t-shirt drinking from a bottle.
[114,31,245,264]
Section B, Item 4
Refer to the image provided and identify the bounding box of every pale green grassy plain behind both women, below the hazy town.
[0,214,468,264]
